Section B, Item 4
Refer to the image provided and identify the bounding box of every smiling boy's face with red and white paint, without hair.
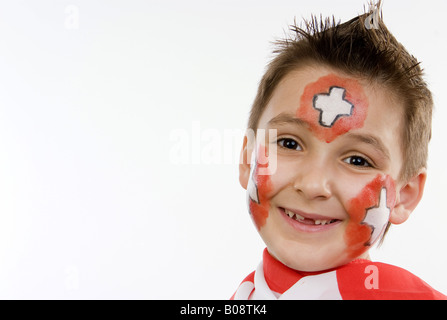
[241,67,410,271]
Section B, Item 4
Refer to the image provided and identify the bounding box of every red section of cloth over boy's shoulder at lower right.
[337,260,447,300]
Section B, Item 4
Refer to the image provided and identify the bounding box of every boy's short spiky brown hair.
[248,1,433,185]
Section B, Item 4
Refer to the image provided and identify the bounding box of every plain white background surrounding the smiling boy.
[0,0,447,299]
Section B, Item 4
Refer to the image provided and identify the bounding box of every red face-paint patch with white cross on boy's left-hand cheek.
[247,145,273,231]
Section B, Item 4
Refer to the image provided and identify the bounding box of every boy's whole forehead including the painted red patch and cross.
[258,67,403,143]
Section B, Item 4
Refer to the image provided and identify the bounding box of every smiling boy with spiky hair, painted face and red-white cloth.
[232,2,447,299]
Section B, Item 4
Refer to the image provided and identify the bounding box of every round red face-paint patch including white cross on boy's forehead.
[296,74,368,143]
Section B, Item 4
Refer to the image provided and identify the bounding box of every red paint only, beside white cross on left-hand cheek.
[249,145,273,230]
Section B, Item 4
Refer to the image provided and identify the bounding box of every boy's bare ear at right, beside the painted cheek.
[390,168,427,224]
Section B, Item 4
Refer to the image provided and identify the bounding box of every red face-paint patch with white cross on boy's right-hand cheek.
[345,175,396,259]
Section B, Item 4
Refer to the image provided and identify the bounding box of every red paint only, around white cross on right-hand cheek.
[345,174,396,259]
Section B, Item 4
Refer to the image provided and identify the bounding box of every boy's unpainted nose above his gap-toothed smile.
[293,160,332,200]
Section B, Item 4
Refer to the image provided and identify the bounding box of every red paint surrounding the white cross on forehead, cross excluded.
[296,74,368,143]
